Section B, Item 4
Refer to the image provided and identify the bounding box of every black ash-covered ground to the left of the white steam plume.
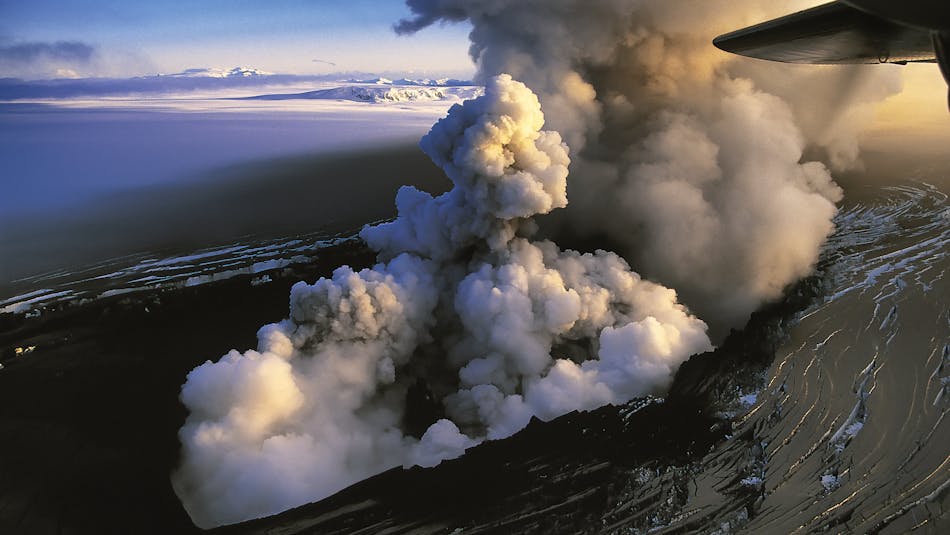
[0,241,373,534]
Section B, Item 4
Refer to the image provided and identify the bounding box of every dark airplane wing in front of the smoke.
[713,2,936,64]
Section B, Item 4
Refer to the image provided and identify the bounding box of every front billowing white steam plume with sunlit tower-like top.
[174,75,711,526]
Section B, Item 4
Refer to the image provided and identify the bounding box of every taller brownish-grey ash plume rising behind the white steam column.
[397,0,899,333]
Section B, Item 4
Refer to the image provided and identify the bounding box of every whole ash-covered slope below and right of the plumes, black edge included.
[215,184,950,534]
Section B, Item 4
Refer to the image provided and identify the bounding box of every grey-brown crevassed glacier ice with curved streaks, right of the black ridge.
[714,183,950,532]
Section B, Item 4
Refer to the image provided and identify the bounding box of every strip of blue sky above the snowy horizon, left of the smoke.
[0,0,473,78]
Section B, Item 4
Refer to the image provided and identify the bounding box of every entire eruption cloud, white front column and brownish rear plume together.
[174,0,908,526]
